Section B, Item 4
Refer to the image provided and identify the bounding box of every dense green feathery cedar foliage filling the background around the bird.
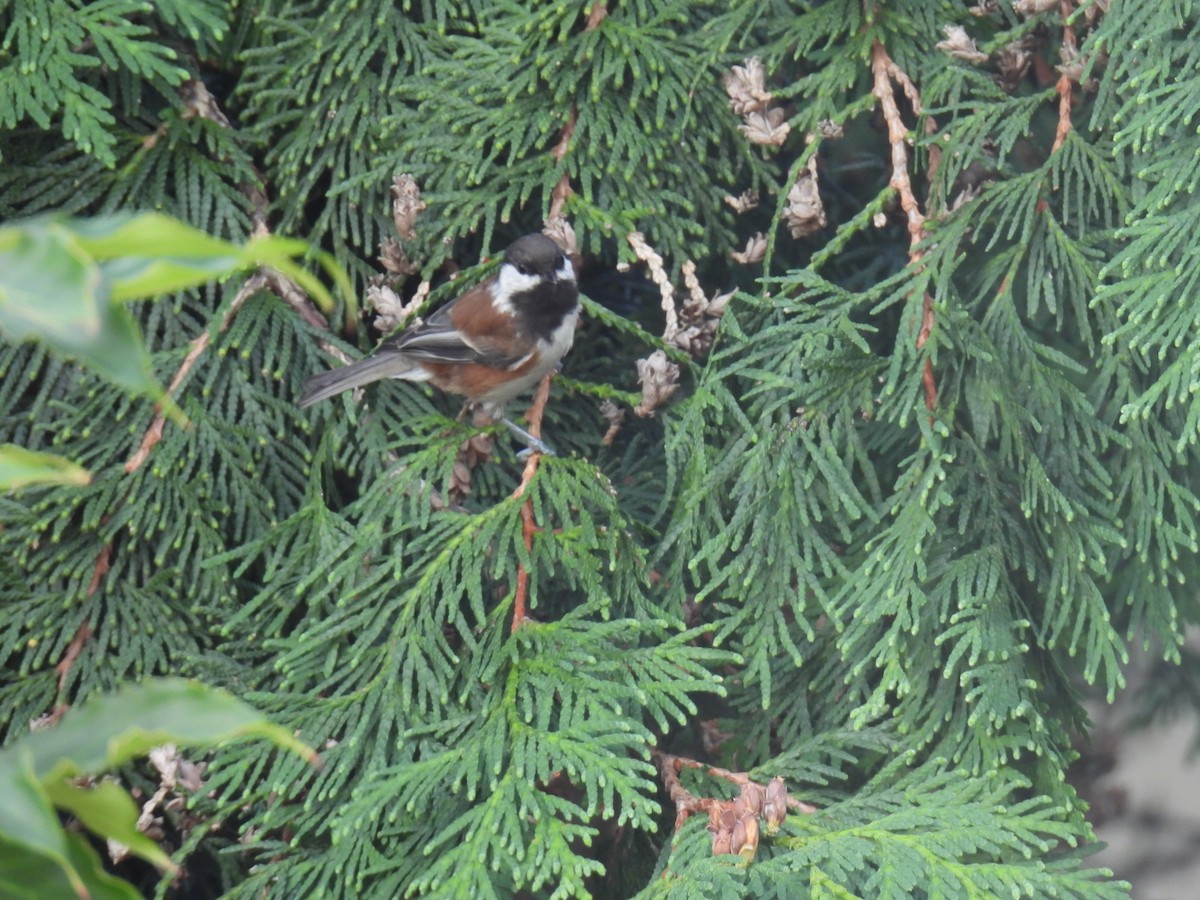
[0,0,1200,898]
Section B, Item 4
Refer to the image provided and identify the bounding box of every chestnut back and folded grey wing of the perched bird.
[379,283,528,368]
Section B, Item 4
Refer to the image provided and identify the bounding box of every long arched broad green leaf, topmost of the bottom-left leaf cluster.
[17,678,316,779]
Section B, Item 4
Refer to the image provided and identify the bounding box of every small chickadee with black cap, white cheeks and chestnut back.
[299,234,580,454]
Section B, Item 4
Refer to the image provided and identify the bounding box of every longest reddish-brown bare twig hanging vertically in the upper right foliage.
[871,41,937,413]
